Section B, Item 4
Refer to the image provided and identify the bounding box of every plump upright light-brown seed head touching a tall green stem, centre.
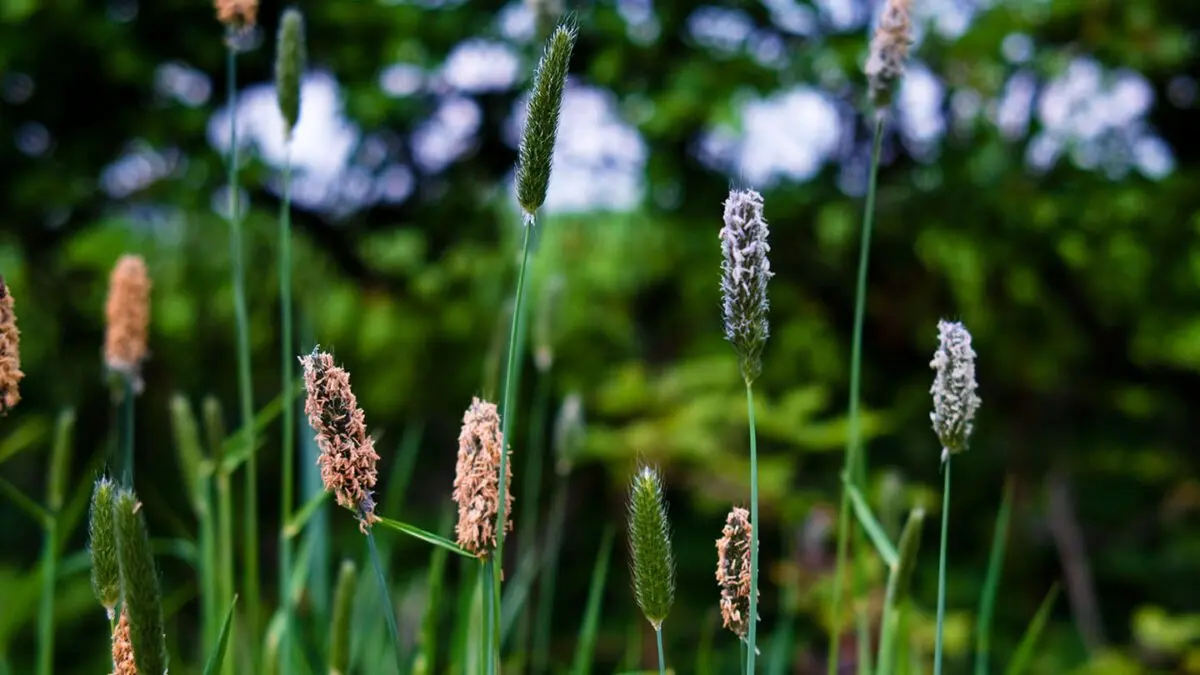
[454,398,512,558]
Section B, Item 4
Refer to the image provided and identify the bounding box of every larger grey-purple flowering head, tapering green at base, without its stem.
[720,190,774,384]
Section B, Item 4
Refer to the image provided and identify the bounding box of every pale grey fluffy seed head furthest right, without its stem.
[929,321,980,461]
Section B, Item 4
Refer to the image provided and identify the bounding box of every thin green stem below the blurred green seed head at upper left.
[280,142,296,673]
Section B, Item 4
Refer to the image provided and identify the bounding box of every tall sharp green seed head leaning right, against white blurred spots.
[517,24,577,221]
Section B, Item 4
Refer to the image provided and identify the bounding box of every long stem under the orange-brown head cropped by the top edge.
[226,41,259,669]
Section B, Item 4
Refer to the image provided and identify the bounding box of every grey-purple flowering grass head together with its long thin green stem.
[720,184,774,675]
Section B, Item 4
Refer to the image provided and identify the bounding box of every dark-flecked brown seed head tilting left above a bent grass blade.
[300,350,379,534]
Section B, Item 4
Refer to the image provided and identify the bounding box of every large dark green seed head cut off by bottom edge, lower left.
[113,489,169,675]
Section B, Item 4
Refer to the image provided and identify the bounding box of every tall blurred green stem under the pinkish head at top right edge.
[827,115,883,675]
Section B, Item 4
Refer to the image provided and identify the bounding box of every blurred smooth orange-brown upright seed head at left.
[104,255,150,388]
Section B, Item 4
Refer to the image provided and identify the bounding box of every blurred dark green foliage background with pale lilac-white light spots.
[0,0,1200,673]
